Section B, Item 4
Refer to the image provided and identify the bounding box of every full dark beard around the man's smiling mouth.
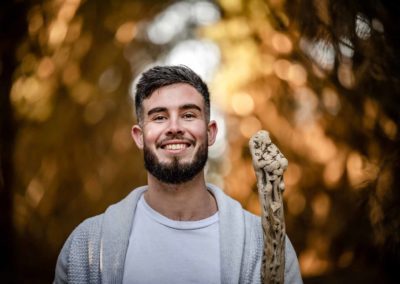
[143,141,208,184]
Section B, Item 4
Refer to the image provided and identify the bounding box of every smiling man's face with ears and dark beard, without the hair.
[132,84,217,184]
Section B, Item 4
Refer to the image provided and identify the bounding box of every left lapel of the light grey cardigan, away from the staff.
[100,187,146,284]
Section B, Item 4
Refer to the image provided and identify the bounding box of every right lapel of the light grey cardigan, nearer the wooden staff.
[207,184,245,284]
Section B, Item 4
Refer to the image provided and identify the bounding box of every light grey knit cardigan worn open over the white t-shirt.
[54,184,302,284]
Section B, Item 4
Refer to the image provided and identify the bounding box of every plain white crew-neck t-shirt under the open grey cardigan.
[123,195,221,284]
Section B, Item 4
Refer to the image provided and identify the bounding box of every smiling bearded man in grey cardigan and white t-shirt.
[55,66,302,284]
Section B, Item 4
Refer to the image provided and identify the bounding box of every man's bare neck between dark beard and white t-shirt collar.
[144,172,218,221]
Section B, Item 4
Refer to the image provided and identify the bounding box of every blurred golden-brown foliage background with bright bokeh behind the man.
[0,0,400,283]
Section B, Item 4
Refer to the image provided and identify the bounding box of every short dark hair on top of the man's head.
[135,65,210,122]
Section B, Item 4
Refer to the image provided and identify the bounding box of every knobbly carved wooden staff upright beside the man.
[249,130,288,284]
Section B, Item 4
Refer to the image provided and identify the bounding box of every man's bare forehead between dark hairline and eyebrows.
[143,83,204,113]
